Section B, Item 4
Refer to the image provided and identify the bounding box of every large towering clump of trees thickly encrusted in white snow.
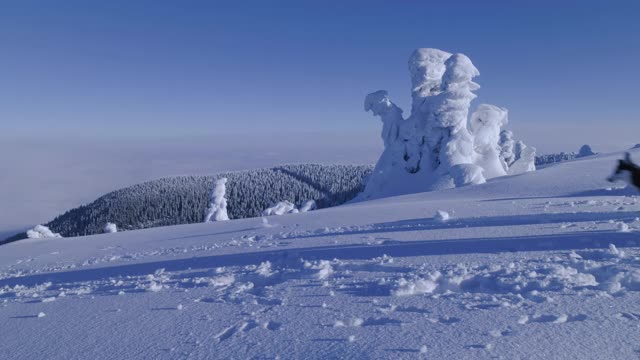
[359,49,535,199]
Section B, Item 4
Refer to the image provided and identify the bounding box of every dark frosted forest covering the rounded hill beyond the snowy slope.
[3,164,372,240]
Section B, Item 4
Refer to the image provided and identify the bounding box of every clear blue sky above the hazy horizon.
[0,0,640,142]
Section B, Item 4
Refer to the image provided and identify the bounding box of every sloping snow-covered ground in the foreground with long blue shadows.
[0,150,640,359]
